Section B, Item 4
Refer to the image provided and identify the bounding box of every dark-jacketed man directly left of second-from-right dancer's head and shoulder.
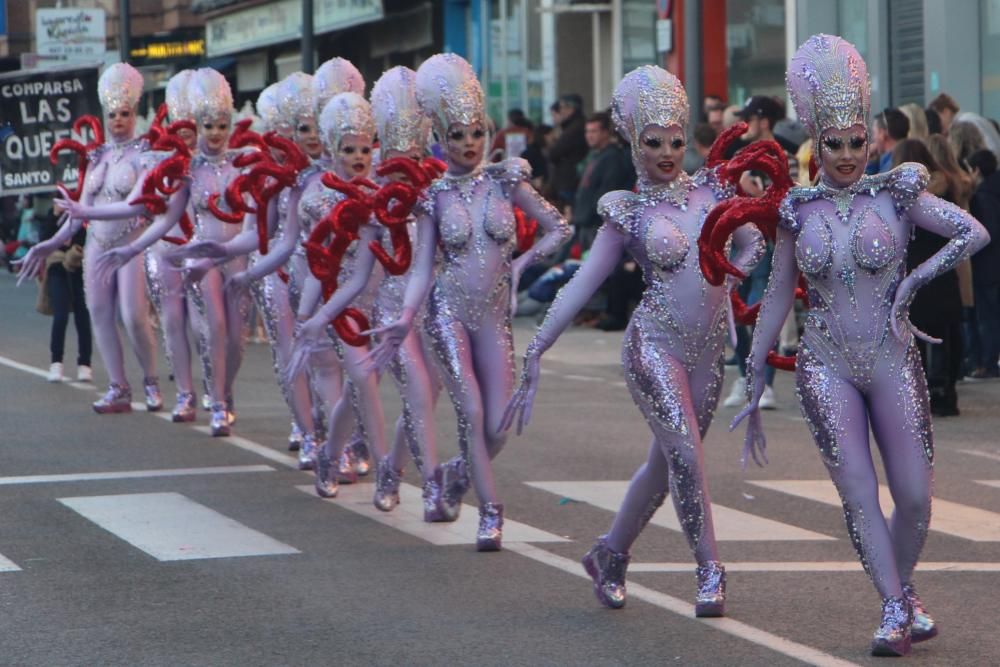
[564,111,635,252]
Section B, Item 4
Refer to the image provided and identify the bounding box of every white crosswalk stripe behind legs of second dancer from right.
[525,481,837,542]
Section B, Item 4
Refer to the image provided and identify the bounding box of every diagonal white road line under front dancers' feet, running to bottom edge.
[504,540,856,667]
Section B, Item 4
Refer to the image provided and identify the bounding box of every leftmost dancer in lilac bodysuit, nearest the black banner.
[21,63,163,413]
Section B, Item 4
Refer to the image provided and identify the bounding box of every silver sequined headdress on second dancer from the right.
[611,65,691,162]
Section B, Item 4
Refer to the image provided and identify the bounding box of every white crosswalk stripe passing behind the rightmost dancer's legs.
[750,479,1000,542]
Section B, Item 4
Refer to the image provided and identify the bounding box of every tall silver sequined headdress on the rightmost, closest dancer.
[786,34,871,146]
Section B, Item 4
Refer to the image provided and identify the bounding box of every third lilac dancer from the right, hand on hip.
[373,53,570,551]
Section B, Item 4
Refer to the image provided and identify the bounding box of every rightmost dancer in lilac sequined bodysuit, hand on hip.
[734,35,989,655]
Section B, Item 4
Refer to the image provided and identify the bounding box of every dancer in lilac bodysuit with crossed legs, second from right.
[505,66,764,616]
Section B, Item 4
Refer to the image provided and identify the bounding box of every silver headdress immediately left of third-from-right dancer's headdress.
[372,67,430,154]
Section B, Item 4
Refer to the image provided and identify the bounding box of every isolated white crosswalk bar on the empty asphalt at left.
[59,493,300,561]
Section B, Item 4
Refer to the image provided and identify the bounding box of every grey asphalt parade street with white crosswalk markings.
[0,273,1000,667]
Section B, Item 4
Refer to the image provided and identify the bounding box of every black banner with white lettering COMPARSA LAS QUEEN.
[0,67,101,196]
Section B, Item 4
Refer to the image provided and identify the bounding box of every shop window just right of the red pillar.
[726,0,786,105]
